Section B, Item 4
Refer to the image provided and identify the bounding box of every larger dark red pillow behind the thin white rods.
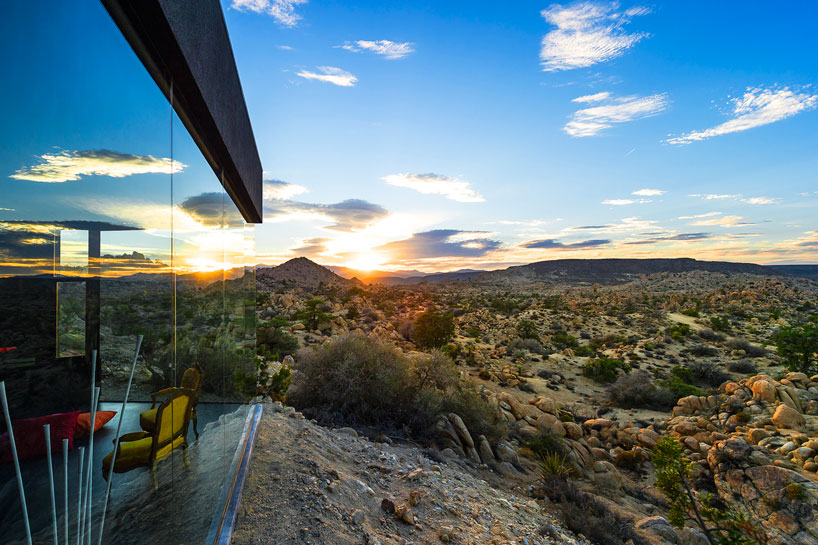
[0,411,80,462]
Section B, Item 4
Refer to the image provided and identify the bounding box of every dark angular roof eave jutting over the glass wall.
[102,0,262,223]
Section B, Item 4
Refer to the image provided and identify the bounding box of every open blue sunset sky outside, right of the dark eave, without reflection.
[222,0,818,271]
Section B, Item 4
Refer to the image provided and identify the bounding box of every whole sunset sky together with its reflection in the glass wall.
[0,0,818,275]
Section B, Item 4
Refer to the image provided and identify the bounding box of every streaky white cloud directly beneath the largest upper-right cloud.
[563,93,668,137]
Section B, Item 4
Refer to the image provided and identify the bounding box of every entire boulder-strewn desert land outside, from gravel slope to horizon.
[228,258,818,545]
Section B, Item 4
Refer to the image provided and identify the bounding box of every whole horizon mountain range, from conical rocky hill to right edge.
[256,257,818,287]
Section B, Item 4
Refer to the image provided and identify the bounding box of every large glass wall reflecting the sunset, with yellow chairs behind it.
[0,0,255,544]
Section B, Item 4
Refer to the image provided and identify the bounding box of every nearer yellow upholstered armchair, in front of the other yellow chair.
[102,388,193,490]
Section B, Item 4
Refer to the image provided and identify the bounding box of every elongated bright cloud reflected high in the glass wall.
[11,150,187,183]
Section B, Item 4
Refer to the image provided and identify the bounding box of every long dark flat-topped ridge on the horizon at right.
[471,258,776,284]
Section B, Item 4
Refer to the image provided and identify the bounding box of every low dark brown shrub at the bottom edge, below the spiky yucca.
[540,475,649,545]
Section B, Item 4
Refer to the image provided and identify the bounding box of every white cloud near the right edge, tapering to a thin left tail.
[667,87,818,144]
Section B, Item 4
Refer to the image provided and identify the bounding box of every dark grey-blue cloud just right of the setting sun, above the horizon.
[374,229,501,259]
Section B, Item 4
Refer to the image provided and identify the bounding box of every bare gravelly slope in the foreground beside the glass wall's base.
[232,403,587,545]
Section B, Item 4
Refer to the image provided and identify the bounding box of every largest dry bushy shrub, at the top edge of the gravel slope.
[288,333,507,442]
